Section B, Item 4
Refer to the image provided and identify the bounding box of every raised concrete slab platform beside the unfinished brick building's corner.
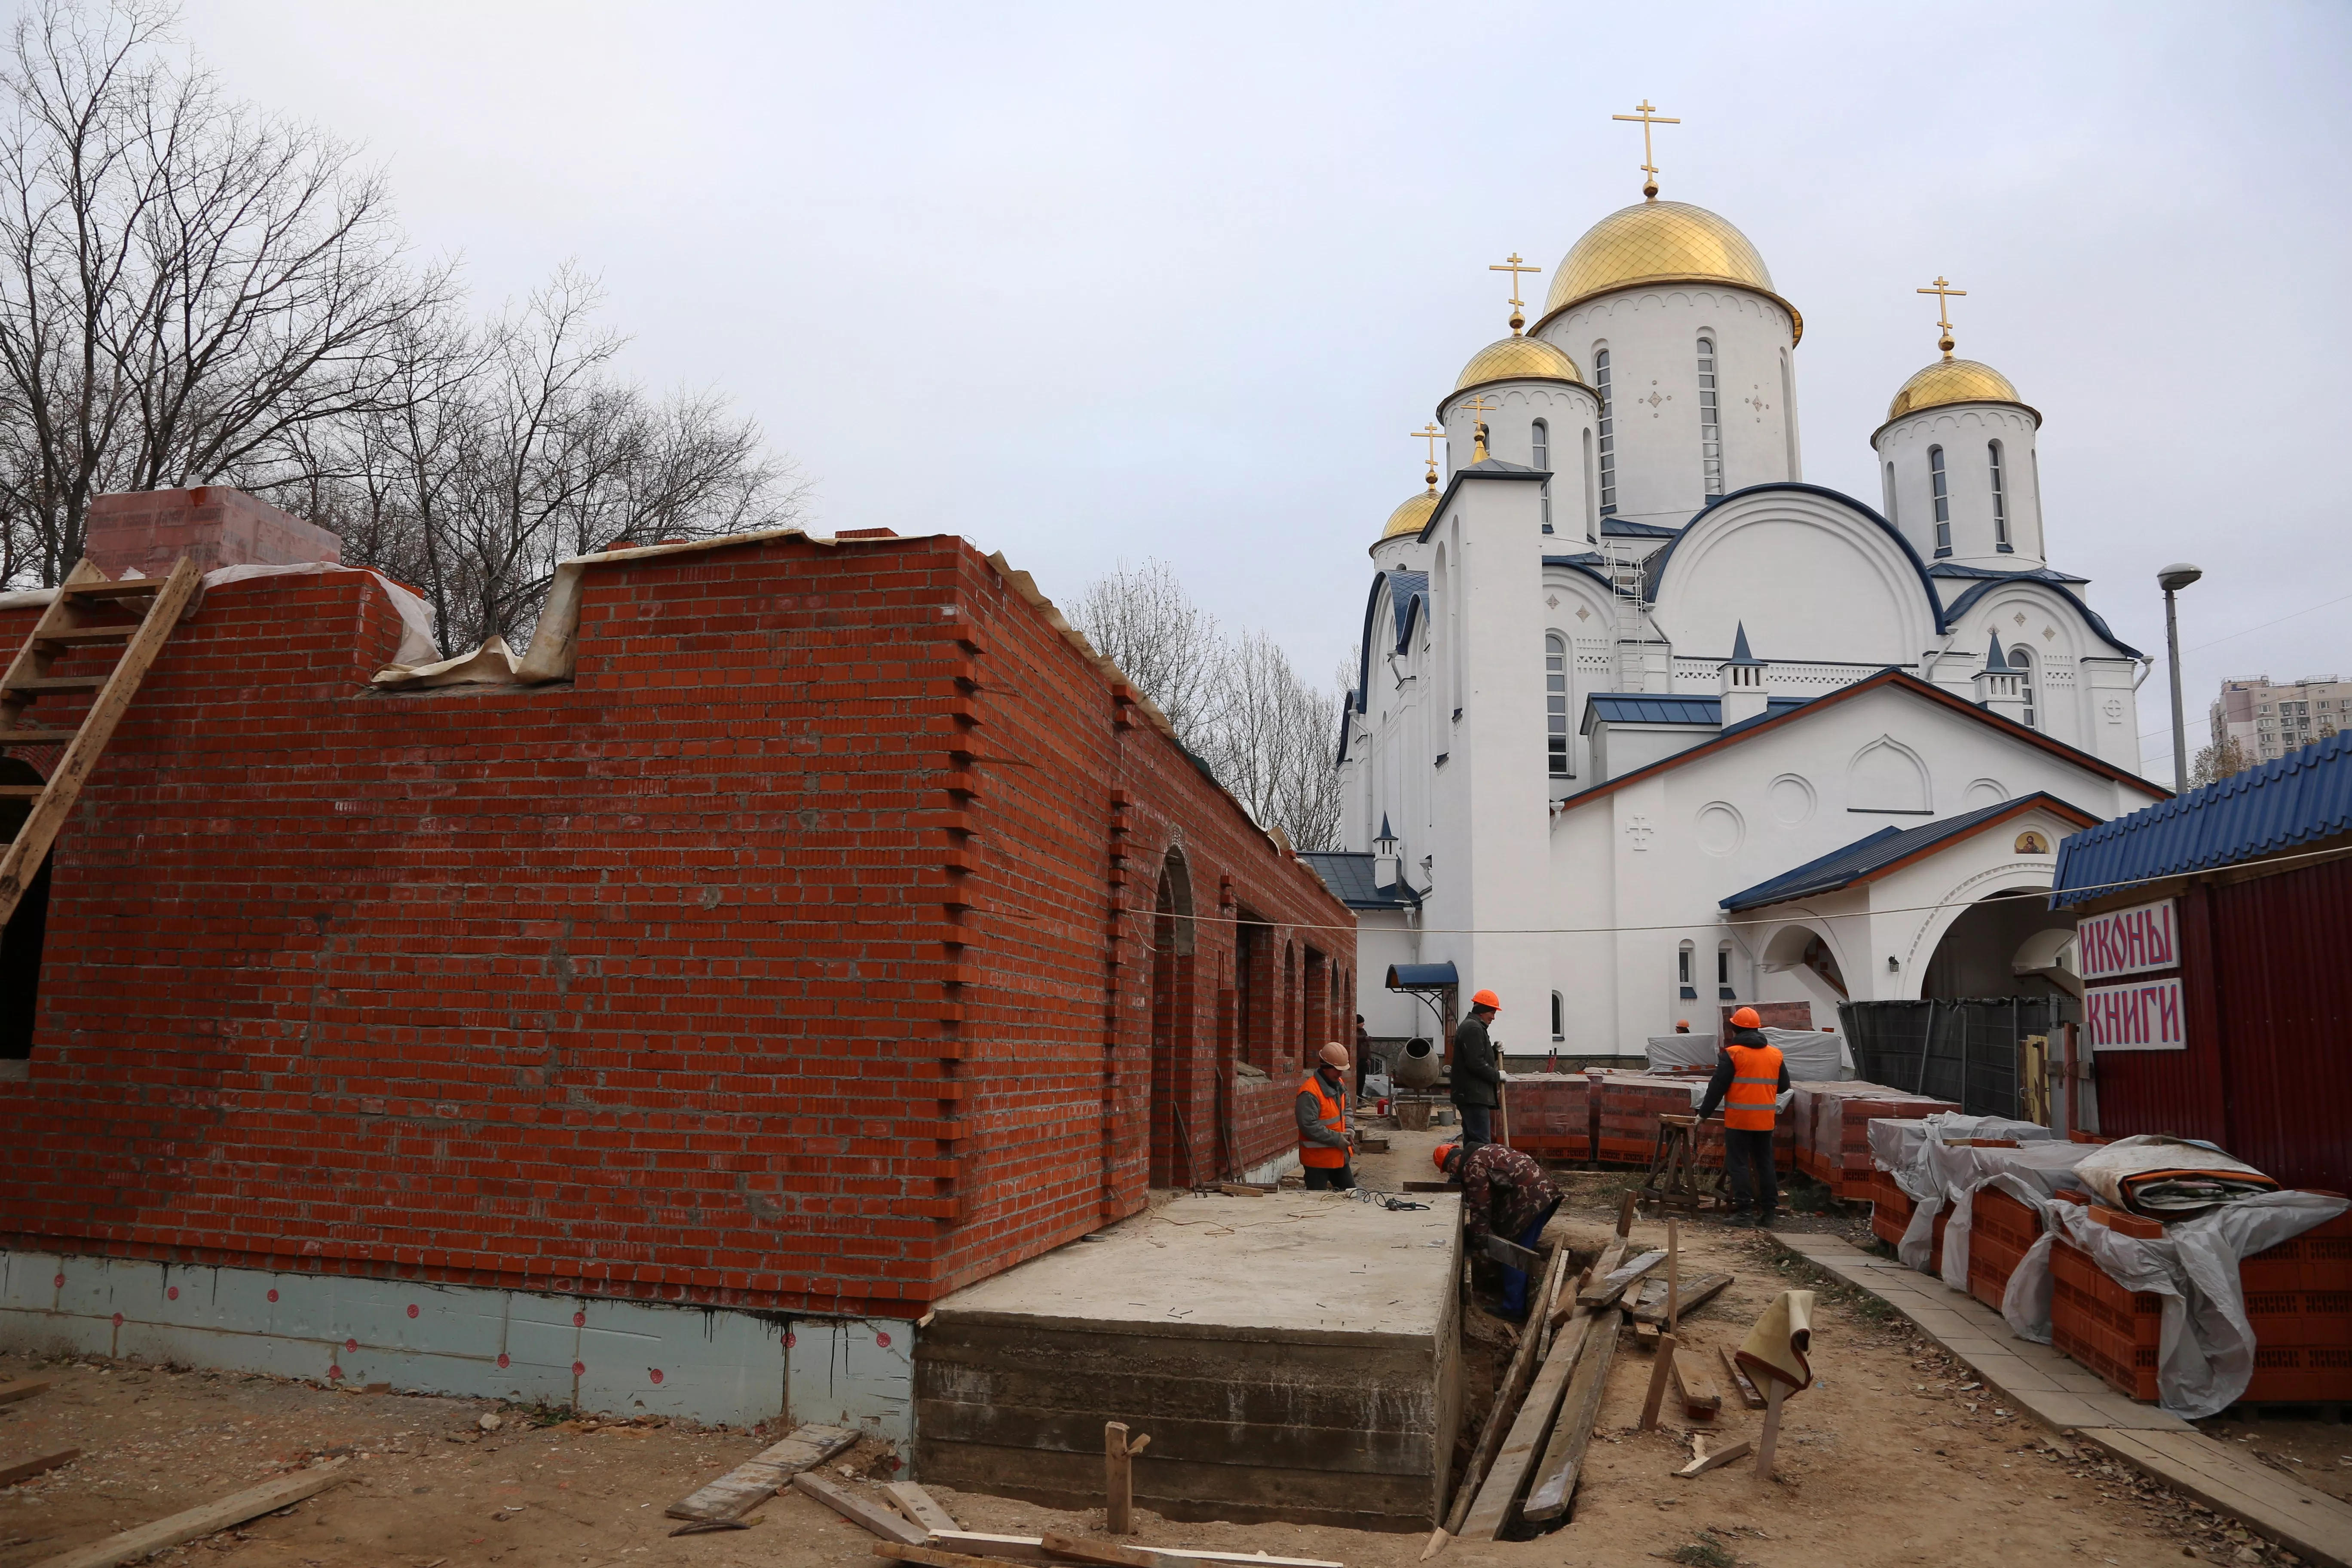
[915,1192,1461,1530]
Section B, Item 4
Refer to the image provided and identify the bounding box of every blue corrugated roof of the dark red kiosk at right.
[2051,731,2352,910]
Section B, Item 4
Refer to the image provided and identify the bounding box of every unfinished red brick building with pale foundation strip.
[0,491,1355,1429]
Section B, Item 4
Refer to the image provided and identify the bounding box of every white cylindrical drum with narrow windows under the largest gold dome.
[1540,285,1795,527]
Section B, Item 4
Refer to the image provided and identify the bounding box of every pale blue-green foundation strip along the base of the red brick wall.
[0,1251,915,1451]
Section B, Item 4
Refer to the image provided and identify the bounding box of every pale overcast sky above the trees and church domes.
[181,0,2352,776]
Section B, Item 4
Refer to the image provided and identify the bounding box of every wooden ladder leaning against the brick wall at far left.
[0,555,205,926]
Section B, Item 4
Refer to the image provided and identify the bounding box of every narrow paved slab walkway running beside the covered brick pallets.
[1773,1232,2352,1568]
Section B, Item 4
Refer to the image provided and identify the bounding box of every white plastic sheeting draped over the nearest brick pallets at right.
[2002,1182,2352,1420]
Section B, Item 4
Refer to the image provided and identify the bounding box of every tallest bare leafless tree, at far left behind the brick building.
[0,0,449,583]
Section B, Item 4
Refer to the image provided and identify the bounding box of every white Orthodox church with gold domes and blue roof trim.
[1312,147,2166,1058]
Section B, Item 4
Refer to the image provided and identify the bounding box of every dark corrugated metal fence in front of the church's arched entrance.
[1837,997,2072,1117]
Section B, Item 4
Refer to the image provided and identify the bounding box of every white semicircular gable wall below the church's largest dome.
[1651,491,1938,670]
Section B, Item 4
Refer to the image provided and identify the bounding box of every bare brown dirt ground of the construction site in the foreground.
[0,1138,2324,1568]
